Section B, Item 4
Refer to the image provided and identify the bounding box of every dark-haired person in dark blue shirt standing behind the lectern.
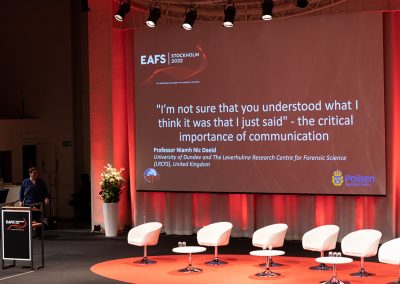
[19,167,49,238]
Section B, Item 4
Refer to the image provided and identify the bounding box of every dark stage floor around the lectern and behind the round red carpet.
[0,224,376,284]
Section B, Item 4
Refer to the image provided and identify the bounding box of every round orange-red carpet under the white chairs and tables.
[90,254,398,284]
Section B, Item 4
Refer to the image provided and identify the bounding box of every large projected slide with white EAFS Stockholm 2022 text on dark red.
[132,13,386,195]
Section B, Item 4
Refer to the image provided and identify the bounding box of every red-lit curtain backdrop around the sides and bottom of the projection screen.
[89,5,400,240]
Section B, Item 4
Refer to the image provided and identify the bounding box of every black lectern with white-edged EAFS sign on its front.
[1,202,44,270]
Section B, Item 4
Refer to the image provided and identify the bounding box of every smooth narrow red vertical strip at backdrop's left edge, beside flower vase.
[88,1,113,224]
